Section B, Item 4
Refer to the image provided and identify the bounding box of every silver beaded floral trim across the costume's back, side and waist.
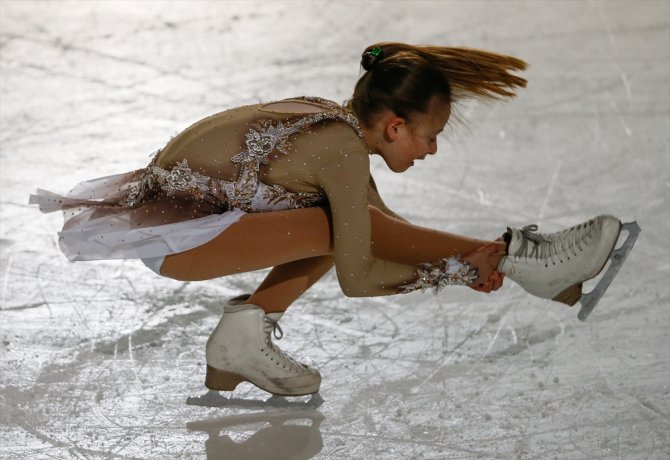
[122,98,362,212]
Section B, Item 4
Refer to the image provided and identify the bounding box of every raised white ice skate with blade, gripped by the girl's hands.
[498,216,640,321]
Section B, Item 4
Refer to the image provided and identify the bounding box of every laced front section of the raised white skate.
[513,219,595,266]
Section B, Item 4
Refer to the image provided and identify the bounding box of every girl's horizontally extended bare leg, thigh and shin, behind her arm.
[161,206,504,281]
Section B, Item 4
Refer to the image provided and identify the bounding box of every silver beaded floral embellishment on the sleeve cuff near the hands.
[400,257,479,294]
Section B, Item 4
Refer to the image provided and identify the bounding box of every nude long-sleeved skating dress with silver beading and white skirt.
[31,98,484,296]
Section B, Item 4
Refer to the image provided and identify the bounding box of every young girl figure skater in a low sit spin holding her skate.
[31,43,632,395]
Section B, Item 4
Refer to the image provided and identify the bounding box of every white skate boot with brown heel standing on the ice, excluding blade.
[205,295,321,396]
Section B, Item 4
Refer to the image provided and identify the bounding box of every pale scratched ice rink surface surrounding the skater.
[0,0,670,460]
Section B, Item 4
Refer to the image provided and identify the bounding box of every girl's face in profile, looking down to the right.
[365,96,451,172]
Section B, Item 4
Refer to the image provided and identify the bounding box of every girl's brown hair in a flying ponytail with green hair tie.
[347,42,527,125]
